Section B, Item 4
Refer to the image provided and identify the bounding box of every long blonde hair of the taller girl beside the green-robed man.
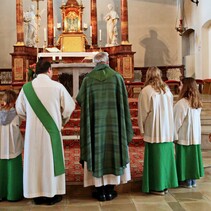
[144,67,167,93]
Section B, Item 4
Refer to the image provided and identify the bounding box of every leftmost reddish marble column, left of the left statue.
[15,0,24,46]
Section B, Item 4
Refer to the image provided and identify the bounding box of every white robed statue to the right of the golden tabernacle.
[104,4,119,46]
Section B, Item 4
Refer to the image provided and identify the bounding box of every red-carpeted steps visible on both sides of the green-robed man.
[62,98,144,184]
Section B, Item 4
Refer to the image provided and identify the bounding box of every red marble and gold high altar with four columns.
[11,0,135,89]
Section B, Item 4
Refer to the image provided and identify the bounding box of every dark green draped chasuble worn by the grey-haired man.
[76,64,133,178]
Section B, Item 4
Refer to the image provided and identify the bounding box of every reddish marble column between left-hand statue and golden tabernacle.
[47,0,54,47]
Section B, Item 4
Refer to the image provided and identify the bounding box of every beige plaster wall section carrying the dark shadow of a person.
[129,0,181,66]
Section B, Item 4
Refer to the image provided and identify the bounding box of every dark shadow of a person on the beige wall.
[139,30,170,67]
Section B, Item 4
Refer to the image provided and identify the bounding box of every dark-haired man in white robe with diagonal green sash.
[16,60,75,205]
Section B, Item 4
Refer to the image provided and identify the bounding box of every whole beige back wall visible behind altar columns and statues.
[0,0,182,68]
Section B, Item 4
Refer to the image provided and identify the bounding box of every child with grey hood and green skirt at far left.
[0,90,23,201]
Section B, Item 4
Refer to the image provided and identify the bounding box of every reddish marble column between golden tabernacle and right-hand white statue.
[91,0,97,47]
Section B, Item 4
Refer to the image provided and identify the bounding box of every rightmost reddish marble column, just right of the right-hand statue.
[121,0,129,44]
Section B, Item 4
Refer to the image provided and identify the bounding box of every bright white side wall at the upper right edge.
[185,0,211,79]
